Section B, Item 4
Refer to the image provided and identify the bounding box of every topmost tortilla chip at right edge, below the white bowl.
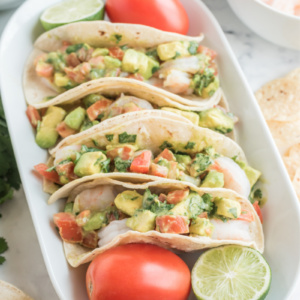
[255,69,300,122]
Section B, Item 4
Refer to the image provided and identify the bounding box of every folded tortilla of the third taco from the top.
[49,115,246,203]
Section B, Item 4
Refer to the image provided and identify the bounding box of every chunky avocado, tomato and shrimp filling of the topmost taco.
[35,41,219,98]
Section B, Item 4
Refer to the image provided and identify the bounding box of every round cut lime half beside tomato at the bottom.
[192,245,272,300]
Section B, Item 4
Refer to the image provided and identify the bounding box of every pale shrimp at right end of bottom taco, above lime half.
[210,219,253,241]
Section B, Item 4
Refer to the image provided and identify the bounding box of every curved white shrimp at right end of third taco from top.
[209,157,251,198]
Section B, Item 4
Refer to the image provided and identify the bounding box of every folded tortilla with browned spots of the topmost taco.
[23,21,221,108]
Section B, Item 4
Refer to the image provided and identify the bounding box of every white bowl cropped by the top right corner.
[228,0,300,50]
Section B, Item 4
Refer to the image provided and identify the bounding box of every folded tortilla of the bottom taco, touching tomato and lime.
[53,174,264,267]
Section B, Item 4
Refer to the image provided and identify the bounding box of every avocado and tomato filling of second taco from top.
[26,94,237,148]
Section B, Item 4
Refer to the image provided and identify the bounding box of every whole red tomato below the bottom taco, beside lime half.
[86,244,191,300]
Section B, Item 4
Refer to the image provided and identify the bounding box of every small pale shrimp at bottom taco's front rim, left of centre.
[98,219,131,247]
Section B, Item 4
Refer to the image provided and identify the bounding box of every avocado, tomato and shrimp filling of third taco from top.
[35,142,261,197]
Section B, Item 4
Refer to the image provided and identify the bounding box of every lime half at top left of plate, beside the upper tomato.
[40,0,104,30]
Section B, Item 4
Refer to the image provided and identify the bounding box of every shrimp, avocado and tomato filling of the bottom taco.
[54,185,254,248]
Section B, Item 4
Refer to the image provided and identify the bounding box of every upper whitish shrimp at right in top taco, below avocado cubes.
[157,56,200,78]
